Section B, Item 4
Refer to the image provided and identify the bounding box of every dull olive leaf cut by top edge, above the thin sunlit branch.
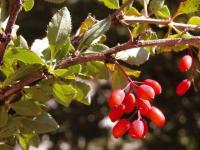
[149,0,165,13]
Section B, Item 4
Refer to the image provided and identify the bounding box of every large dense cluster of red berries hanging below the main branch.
[108,79,165,138]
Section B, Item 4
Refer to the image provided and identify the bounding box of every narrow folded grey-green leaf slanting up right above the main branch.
[78,19,111,50]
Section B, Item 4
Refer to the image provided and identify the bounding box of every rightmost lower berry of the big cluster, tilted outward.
[148,106,166,127]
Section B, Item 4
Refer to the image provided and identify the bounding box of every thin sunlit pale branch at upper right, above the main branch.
[123,16,200,31]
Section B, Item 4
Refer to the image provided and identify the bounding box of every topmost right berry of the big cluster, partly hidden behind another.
[144,79,162,95]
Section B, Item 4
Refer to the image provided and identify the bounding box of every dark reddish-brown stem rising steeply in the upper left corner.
[0,0,22,63]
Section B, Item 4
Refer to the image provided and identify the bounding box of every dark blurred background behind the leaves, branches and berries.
[17,0,200,150]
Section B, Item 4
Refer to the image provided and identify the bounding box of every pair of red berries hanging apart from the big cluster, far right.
[176,55,192,96]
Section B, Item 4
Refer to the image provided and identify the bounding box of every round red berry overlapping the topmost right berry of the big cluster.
[136,84,155,101]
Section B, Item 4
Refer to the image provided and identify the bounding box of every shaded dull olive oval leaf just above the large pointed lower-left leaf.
[11,100,43,116]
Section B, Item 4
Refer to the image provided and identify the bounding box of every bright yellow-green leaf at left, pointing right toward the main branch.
[4,47,45,65]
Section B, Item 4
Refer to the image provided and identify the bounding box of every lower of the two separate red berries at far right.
[176,79,191,96]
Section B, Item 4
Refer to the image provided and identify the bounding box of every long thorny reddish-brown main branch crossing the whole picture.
[0,36,200,100]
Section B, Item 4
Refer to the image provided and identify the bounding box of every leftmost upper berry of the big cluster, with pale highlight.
[108,89,125,108]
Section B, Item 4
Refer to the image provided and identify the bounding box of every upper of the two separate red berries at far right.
[178,55,192,72]
